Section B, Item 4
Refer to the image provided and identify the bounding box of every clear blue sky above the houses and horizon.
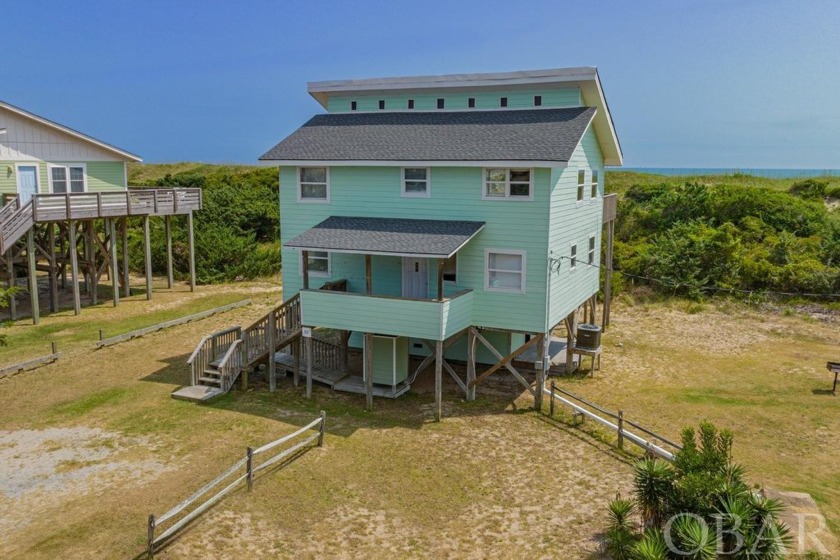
[6,0,840,169]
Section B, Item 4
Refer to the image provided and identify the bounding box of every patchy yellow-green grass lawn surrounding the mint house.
[0,283,840,558]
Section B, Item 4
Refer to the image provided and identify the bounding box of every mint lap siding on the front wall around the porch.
[280,167,550,332]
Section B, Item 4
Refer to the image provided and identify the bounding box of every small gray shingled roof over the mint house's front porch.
[284,216,484,258]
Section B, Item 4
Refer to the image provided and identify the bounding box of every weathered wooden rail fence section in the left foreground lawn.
[147,410,327,558]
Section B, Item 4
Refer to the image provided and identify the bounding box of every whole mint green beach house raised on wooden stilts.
[260,68,622,418]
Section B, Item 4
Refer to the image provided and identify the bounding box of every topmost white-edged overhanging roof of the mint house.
[308,66,624,165]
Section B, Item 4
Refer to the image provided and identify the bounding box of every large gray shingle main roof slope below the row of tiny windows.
[260,107,595,162]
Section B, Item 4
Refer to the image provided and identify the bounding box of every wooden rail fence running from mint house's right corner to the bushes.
[543,381,682,461]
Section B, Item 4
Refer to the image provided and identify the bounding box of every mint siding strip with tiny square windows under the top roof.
[327,88,583,113]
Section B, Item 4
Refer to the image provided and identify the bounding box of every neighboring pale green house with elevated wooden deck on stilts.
[0,102,202,323]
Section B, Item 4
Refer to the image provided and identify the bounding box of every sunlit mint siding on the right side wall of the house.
[547,127,604,328]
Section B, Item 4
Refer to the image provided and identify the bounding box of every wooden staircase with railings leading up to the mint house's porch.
[172,295,301,401]
